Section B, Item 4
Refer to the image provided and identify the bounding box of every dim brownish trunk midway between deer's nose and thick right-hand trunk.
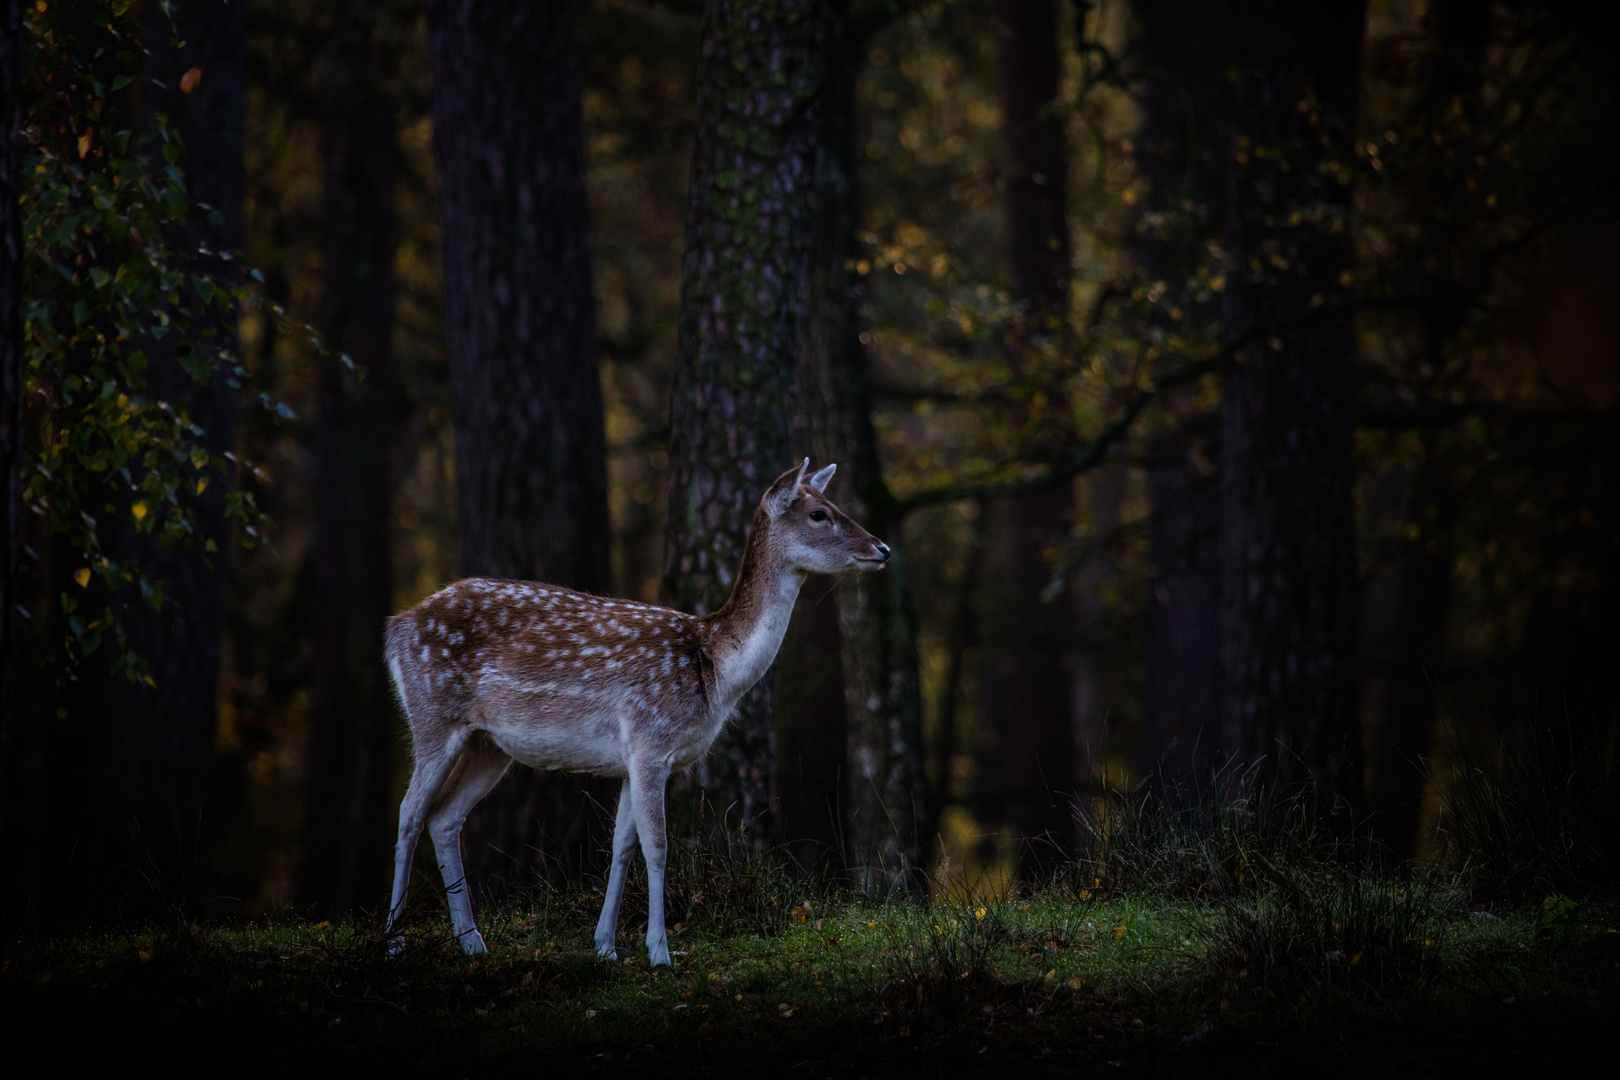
[980,0,1077,873]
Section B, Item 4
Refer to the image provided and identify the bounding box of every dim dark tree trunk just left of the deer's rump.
[298,18,400,912]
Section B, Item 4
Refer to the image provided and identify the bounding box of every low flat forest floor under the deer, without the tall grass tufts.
[0,894,1620,1078]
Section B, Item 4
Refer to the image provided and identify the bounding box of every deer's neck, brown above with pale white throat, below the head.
[706,523,805,716]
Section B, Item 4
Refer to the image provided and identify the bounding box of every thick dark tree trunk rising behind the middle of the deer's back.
[428,0,612,886]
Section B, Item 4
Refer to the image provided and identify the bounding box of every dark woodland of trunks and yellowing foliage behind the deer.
[0,0,1620,925]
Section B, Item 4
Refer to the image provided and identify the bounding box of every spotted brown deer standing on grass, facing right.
[386,458,889,965]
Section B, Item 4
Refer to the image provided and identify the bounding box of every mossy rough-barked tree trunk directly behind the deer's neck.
[664,0,823,844]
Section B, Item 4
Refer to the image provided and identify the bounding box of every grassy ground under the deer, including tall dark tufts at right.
[12,751,1620,1080]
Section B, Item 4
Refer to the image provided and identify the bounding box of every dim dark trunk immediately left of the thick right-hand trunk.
[1134,0,1228,785]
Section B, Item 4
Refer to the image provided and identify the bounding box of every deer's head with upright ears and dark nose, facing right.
[753,458,889,573]
